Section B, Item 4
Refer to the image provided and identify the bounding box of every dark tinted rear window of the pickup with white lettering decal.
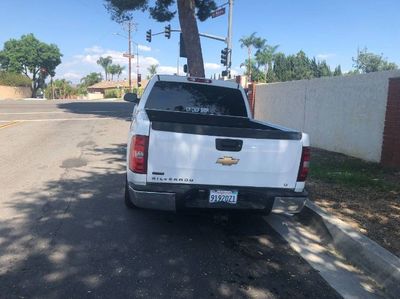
[145,81,247,117]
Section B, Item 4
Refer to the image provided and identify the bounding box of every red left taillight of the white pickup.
[129,135,149,174]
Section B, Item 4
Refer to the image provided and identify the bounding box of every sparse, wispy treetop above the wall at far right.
[353,48,398,74]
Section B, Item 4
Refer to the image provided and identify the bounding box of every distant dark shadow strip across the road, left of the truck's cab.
[57,101,134,119]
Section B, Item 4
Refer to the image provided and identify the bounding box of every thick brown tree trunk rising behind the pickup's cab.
[178,0,205,78]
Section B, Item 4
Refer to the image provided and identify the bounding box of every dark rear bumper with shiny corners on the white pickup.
[129,184,308,214]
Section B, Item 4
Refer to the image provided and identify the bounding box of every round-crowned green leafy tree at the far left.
[0,33,62,97]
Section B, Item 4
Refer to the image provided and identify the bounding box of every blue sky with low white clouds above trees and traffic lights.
[0,0,400,82]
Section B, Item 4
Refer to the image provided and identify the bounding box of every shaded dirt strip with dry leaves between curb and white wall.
[307,149,400,257]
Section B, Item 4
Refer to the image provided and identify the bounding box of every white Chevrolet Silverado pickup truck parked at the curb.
[125,75,310,214]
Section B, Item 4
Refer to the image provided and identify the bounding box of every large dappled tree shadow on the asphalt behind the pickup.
[0,144,339,298]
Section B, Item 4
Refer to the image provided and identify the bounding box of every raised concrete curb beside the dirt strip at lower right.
[299,200,400,298]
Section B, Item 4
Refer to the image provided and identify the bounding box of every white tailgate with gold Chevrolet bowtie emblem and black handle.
[147,127,302,189]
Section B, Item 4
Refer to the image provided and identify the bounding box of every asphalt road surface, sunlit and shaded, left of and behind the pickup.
[0,101,339,298]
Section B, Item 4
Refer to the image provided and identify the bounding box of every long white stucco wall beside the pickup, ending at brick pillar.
[255,71,400,162]
